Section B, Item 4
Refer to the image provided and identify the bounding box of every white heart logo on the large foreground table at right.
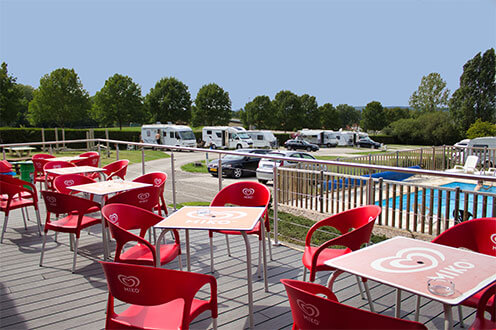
[370,247,445,273]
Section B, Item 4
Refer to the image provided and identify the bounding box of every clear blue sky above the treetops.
[0,0,496,109]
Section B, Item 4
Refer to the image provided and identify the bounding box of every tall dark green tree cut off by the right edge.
[450,48,496,134]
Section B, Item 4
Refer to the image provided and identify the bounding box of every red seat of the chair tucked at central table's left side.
[120,244,180,266]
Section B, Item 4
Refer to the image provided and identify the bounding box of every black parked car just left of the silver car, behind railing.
[207,149,270,179]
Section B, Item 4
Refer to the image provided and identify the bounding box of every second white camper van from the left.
[202,126,253,149]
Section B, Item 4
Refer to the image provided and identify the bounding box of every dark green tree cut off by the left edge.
[0,62,22,126]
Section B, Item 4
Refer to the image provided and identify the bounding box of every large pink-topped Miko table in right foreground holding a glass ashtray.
[325,237,496,329]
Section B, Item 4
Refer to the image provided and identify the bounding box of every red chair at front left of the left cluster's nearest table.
[40,190,102,273]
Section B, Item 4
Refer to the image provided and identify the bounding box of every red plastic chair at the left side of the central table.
[102,204,182,269]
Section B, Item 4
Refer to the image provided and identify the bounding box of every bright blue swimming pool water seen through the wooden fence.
[376,182,496,218]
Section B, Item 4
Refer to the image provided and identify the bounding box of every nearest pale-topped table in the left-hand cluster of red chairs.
[67,180,151,260]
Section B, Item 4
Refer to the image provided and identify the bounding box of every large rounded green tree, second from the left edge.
[28,68,91,127]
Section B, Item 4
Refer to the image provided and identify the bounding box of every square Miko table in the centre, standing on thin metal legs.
[154,206,268,328]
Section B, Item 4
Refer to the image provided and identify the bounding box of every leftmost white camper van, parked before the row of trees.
[141,124,196,148]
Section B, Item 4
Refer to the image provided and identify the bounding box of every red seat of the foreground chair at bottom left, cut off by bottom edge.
[109,299,208,329]
